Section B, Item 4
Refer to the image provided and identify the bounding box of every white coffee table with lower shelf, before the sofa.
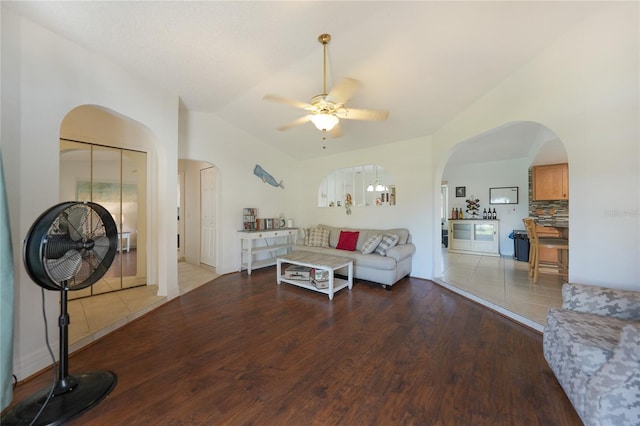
[276,251,353,300]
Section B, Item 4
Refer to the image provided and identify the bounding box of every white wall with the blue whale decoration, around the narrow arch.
[179,111,301,274]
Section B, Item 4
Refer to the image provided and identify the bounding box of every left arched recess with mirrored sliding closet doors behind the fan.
[59,105,154,299]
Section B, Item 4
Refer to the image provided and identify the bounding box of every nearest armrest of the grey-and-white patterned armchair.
[584,324,640,425]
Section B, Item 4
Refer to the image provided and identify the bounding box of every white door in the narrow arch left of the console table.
[200,167,216,268]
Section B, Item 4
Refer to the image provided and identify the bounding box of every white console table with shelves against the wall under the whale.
[238,228,298,275]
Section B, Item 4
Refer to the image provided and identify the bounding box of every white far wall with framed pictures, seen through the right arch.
[442,159,529,256]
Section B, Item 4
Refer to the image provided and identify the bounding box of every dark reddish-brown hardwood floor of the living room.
[6,267,581,425]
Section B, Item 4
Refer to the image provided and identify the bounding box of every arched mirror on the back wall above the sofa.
[318,164,396,207]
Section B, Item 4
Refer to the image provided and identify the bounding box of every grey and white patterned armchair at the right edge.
[543,284,640,426]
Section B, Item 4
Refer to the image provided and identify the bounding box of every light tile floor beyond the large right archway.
[435,249,566,331]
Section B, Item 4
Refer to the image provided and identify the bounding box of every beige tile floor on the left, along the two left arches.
[68,262,219,353]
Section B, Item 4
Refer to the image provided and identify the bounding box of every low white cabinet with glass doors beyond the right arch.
[449,219,500,256]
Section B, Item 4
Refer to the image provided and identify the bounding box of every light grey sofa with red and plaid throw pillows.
[293,225,416,290]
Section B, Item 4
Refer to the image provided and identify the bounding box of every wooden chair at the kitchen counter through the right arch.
[522,217,569,283]
